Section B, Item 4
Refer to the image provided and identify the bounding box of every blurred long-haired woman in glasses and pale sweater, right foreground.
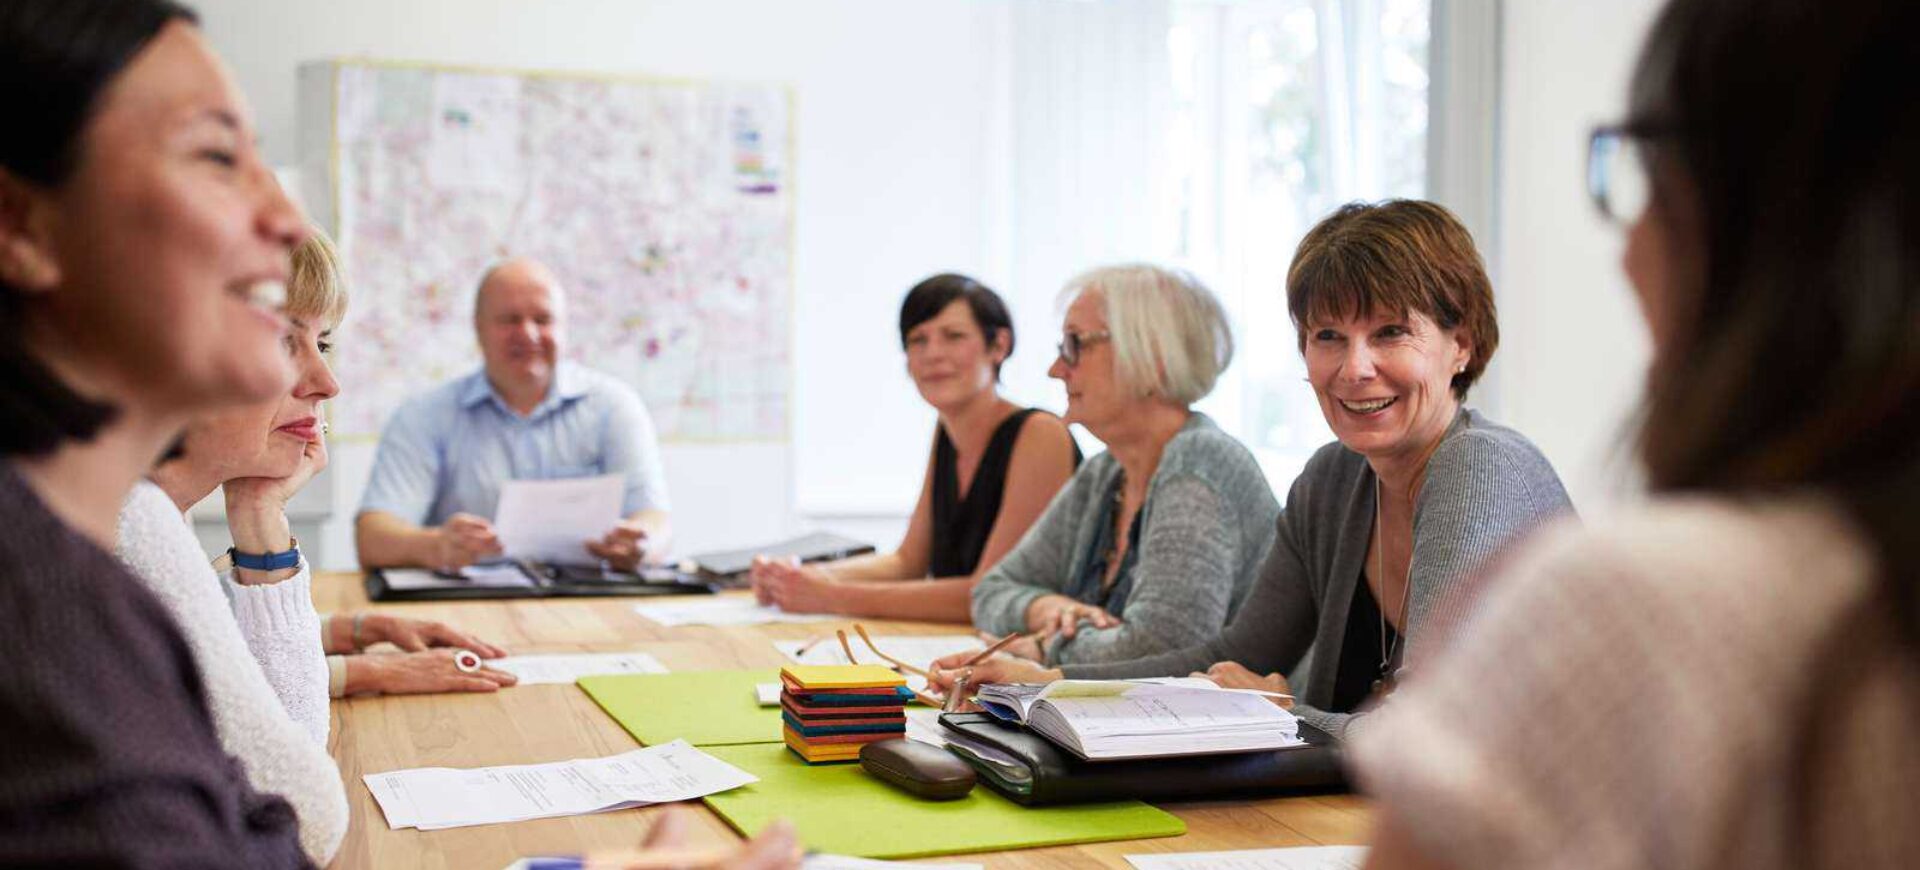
[1356,0,1920,870]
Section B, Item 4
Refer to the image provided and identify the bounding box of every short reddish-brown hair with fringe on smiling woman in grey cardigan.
[1286,200,1500,399]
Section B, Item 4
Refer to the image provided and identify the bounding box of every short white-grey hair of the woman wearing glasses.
[1060,263,1233,405]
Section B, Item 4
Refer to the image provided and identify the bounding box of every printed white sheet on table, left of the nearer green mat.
[365,739,758,832]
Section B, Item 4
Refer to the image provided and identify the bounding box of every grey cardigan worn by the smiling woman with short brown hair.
[1062,409,1572,736]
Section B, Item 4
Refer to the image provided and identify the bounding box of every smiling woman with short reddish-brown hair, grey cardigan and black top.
[937,200,1571,736]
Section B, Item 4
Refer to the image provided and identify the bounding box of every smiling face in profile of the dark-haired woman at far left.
[15,23,307,415]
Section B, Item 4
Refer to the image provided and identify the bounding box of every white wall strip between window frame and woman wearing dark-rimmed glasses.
[1494,0,1659,513]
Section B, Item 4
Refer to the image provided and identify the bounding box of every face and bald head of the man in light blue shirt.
[474,259,563,396]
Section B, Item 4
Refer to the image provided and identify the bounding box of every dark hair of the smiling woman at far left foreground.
[0,0,198,455]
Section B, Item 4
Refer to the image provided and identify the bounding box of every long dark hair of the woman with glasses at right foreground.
[1628,0,1920,641]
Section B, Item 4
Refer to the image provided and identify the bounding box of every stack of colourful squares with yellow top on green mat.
[780,665,914,764]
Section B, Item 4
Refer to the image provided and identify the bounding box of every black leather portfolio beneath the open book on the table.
[941,713,1348,807]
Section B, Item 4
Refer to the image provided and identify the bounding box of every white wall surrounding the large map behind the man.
[196,0,1021,567]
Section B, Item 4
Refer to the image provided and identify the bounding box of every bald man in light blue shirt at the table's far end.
[353,259,670,570]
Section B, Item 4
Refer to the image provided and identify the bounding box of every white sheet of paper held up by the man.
[493,474,626,565]
